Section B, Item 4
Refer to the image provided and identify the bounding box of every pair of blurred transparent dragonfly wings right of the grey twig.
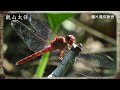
[75,48,116,76]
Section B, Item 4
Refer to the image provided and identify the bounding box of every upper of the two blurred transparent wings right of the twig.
[77,53,114,68]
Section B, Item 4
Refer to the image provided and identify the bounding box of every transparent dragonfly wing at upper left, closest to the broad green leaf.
[28,13,55,41]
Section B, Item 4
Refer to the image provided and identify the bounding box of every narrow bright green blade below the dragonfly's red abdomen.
[35,52,50,78]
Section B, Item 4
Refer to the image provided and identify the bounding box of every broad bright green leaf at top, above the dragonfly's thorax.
[46,13,75,32]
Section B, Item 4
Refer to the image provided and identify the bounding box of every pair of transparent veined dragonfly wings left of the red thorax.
[11,13,55,52]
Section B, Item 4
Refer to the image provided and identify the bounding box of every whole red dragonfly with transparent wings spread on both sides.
[11,13,113,76]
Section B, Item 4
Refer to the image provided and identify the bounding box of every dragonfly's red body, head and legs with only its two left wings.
[11,14,75,65]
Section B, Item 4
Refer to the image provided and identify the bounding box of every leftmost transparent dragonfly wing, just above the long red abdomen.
[11,20,48,52]
